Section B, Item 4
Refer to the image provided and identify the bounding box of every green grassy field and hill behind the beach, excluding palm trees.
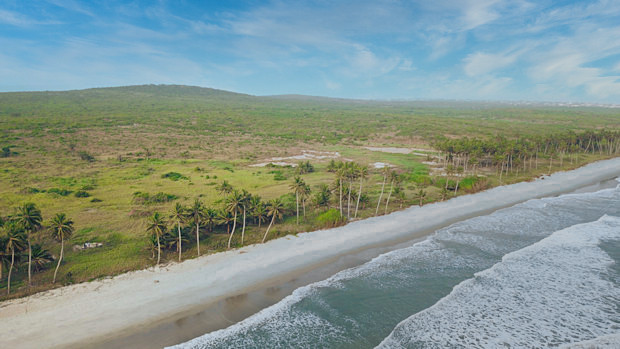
[0,85,620,296]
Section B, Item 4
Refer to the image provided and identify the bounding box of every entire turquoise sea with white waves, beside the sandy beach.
[172,181,620,348]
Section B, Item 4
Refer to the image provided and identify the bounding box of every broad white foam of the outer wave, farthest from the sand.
[378,215,620,348]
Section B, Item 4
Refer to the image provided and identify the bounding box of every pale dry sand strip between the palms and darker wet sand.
[0,158,620,348]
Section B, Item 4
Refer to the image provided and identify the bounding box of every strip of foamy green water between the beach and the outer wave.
[170,185,620,348]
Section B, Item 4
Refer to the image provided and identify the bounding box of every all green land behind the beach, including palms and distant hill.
[0,86,620,297]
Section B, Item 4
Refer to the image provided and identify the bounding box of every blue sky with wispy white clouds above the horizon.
[0,0,620,104]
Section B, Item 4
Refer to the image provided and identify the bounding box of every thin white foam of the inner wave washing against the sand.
[175,185,620,348]
